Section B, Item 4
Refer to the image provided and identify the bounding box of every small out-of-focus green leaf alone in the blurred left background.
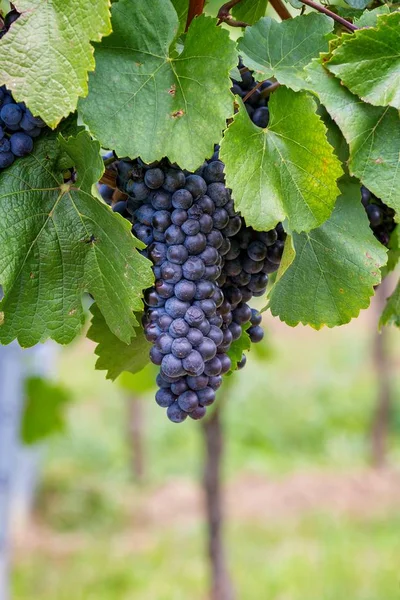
[21,377,71,445]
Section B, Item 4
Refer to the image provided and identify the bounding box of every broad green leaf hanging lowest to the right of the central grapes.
[269,183,386,329]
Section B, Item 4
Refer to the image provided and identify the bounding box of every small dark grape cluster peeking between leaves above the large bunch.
[231,59,272,128]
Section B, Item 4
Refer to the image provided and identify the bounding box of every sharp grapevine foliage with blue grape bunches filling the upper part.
[0,0,400,422]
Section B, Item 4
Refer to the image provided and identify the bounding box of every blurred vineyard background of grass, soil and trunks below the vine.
[0,278,400,600]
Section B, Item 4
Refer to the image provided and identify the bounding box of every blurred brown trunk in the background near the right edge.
[371,278,393,468]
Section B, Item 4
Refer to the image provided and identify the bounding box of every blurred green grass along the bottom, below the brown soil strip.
[14,514,400,600]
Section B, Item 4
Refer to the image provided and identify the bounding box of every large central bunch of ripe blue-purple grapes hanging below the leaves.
[113,149,283,422]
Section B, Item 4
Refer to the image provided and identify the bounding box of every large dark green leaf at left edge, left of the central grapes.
[0,123,153,347]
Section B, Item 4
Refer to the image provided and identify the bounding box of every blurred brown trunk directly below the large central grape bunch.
[203,404,235,600]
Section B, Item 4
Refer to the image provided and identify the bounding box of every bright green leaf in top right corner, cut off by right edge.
[325,12,400,109]
